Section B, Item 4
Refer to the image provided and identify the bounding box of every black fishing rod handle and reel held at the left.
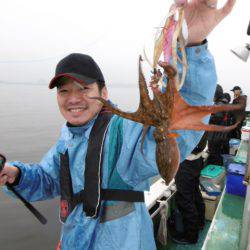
[0,154,47,225]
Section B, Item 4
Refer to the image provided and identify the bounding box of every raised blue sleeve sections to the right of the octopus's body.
[177,41,217,161]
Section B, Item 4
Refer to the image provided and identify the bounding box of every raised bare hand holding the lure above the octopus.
[176,0,236,46]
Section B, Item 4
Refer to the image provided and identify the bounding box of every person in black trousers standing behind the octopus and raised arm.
[172,132,207,244]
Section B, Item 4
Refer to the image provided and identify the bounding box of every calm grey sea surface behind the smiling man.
[0,83,139,250]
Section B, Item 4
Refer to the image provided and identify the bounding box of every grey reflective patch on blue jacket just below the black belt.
[100,201,135,223]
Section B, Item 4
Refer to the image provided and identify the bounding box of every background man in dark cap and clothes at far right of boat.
[230,86,247,139]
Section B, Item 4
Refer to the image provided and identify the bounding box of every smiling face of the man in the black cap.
[57,78,108,126]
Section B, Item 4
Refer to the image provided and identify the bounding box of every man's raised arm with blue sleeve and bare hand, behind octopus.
[117,0,236,186]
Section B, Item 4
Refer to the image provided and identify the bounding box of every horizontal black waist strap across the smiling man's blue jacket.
[72,189,145,204]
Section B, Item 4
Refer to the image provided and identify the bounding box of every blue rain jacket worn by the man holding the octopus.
[5,44,217,250]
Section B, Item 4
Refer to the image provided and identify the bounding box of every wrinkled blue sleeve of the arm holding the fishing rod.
[5,147,60,201]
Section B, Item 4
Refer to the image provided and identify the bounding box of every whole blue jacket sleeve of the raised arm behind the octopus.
[117,41,217,186]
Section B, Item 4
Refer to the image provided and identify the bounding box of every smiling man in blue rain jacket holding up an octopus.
[0,0,235,250]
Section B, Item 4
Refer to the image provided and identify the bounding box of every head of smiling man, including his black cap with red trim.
[52,53,108,125]
